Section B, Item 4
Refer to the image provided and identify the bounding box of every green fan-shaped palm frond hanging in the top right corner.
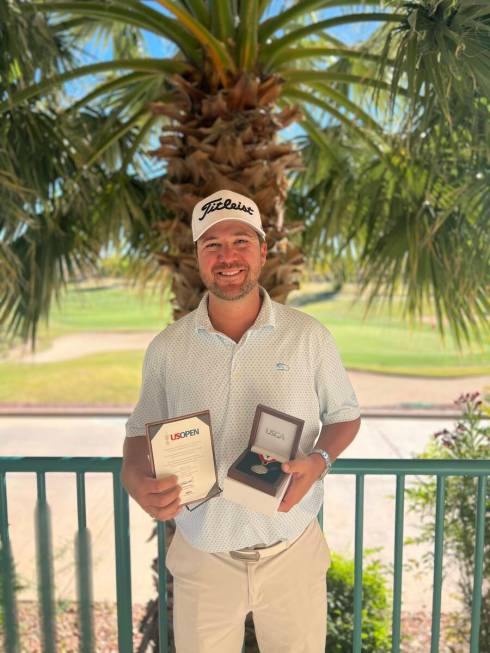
[381,0,490,124]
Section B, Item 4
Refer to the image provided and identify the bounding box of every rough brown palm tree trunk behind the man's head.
[151,73,303,319]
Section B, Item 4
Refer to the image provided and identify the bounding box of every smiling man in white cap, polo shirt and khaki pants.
[122,190,360,653]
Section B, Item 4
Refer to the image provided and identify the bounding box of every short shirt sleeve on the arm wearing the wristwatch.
[315,327,361,426]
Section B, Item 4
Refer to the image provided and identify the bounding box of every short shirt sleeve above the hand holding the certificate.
[126,336,168,438]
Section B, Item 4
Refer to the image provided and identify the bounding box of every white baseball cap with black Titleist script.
[192,190,265,242]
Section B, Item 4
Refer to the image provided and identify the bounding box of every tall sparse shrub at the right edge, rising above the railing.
[407,392,490,653]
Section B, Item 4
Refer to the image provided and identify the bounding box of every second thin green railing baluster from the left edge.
[36,472,56,653]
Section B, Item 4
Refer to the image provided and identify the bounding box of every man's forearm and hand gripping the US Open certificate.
[121,436,182,521]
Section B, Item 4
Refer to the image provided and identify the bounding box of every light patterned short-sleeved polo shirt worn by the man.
[126,288,360,553]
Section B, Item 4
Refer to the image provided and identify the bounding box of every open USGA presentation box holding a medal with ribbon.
[223,404,304,515]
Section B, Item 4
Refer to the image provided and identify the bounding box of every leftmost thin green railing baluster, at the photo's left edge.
[0,472,19,653]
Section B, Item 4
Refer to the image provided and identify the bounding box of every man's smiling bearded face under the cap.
[197,220,267,300]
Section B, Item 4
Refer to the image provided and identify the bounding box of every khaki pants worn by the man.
[167,519,330,653]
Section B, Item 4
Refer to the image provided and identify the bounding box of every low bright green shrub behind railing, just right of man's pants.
[326,553,391,653]
